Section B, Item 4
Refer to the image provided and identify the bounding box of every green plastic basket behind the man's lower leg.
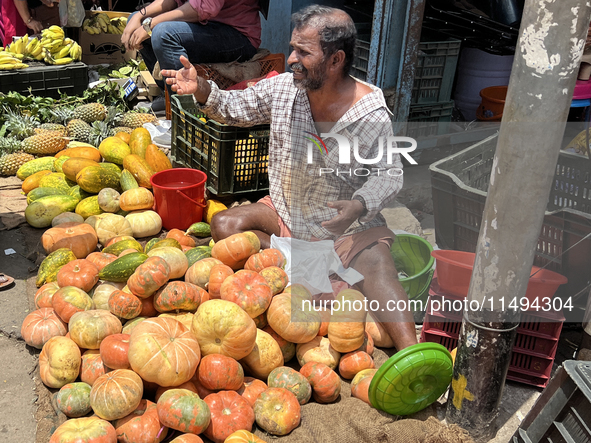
[390,234,435,302]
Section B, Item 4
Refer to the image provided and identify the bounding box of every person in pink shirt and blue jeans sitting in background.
[121,0,261,111]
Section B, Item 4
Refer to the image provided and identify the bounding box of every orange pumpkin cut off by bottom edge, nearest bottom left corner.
[49,420,117,443]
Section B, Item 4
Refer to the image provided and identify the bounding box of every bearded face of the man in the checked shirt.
[287,26,326,91]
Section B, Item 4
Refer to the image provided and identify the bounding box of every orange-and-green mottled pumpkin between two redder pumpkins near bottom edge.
[156,389,211,434]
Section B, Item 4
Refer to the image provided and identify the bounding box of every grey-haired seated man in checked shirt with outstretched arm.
[162,5,417,350]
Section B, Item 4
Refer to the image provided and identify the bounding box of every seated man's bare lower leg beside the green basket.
[350,243,417,351]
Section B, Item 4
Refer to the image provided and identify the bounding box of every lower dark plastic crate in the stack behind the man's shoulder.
[407,100,454,138]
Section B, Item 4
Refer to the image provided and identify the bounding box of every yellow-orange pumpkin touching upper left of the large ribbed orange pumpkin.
[68,309,121,349]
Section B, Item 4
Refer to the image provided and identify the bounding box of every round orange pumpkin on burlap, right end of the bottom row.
[254,388,301,435]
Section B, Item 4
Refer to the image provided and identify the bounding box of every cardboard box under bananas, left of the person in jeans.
[79,11,137,65]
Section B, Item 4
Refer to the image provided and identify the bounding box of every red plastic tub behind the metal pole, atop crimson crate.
[431,250,568,309]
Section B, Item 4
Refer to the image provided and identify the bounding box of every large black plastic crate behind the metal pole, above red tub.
[429,135,591,308]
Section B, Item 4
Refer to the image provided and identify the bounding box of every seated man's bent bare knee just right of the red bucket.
[211,203,281,249]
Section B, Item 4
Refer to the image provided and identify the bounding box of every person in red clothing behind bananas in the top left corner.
[0,0,60,46]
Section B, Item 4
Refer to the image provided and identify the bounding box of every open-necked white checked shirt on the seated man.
[201,73,402,240]
